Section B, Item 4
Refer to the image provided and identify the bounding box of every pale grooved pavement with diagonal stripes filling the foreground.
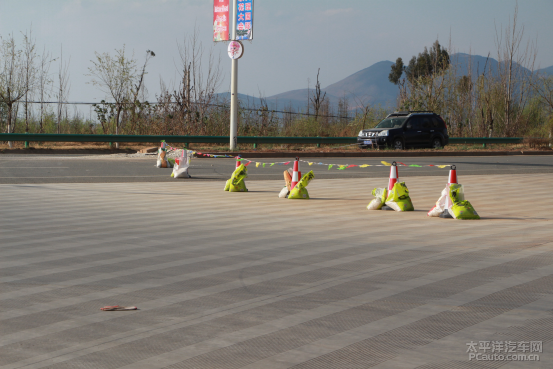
[0,173,553,369]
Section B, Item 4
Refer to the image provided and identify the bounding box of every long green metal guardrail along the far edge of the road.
[0,133,523,147]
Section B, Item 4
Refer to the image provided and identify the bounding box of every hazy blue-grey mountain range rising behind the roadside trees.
[219,53,553,111]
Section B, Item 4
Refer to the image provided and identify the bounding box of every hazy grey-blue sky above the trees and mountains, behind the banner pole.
[0,0,553,101]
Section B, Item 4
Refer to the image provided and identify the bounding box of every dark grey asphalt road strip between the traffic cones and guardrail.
[0,155,553,183]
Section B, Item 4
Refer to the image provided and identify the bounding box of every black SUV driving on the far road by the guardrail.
[357,111,449,150]
